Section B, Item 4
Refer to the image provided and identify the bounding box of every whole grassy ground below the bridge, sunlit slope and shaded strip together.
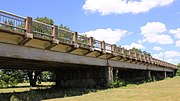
[0,76,180,101]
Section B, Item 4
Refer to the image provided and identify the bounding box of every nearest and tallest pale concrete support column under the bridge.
[106,66,113,86]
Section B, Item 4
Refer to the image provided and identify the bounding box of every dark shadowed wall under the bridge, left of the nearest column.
[55,67,107,88]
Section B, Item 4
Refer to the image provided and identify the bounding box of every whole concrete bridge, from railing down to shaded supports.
[0,11,177,87]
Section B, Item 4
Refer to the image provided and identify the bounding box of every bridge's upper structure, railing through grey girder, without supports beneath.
[0,11,177,71]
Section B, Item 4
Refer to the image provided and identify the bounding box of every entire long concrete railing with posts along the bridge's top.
[0,10,176,68]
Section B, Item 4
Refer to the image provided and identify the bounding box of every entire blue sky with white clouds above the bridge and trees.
[0,0,180,64]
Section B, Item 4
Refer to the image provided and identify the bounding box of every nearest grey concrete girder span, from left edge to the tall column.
[0,43,107,66]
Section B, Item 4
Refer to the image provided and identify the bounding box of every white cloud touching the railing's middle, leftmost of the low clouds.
[82,28,128,44]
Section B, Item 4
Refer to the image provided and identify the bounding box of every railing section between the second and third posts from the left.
[57,28,74,45]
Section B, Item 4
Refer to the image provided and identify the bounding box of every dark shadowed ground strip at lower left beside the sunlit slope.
[0,87,99,101]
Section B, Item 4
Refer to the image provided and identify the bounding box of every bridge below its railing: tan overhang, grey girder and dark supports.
[0,32,174,87]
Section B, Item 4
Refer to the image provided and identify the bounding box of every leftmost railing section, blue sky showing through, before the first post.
[0,10,26,34]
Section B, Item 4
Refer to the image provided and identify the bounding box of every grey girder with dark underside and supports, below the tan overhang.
[0,43,174,88]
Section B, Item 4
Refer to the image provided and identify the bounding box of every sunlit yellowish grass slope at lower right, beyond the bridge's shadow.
[44,77,180,101]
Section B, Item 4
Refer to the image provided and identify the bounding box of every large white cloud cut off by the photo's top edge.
[83,0,174,15]
